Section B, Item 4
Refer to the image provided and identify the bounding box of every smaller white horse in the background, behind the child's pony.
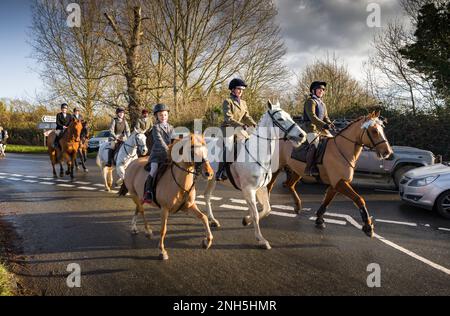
[97,130,148,192]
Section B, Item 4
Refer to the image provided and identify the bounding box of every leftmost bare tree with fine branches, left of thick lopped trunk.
[31,0,108,123]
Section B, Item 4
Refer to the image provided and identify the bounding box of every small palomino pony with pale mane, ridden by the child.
[119,135,214,260]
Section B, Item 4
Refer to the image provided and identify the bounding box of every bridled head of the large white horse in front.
[266,101,306,147]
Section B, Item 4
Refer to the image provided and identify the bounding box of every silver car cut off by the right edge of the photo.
[400,164,450,219]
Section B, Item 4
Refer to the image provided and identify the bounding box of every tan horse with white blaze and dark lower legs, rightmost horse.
[268,112,393,237]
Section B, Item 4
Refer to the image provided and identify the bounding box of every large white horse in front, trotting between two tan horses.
[204,102,306,249]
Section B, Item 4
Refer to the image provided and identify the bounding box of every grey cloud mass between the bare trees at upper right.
[275,0,403,79]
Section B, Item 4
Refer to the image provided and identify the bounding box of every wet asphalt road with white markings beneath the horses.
[0,154,450,296]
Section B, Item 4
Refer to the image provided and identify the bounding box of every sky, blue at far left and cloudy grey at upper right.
[0,0,401,101]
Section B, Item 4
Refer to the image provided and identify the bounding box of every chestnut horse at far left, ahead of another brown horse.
[47,119,83,179]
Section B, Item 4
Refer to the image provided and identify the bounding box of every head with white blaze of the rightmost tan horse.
[361,112,394,159]
